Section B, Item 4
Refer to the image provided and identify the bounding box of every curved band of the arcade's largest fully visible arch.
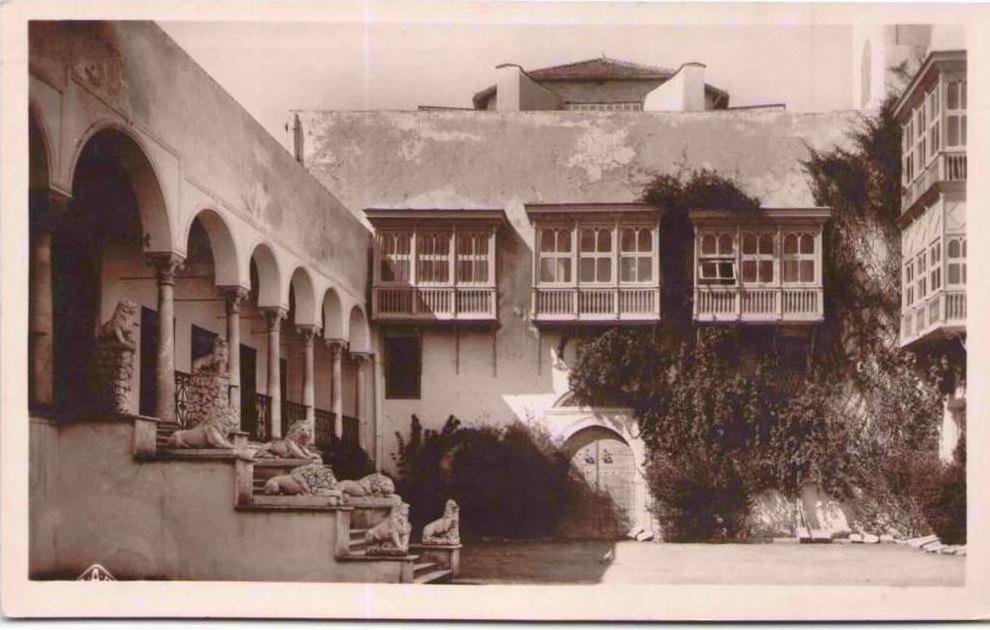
[69,121,175,253]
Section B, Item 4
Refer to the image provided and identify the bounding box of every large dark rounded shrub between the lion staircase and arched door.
[393,416,620,538]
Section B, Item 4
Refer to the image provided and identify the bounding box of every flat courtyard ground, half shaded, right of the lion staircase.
[458,541,966,586]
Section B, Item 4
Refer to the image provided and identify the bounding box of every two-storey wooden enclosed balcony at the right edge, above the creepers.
[894,51,968,346]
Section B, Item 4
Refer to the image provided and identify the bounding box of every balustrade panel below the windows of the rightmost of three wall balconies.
[694,286,825,323]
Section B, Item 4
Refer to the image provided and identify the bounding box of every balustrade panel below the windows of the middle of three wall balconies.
[532,287,660,322]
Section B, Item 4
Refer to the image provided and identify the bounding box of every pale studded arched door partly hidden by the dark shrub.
[564,426,636,535]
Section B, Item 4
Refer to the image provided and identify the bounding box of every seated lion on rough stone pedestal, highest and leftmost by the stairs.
[93,299,137,415]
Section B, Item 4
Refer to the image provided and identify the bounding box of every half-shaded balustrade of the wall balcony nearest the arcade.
[372,286,497,322]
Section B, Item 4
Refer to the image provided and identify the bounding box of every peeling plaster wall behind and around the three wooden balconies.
[300,111,857,470]
